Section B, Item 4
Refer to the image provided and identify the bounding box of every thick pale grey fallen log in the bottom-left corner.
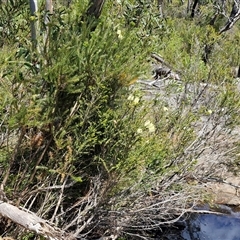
[0,201,76,240]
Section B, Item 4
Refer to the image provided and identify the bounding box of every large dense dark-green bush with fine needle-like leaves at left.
[1,0,154,204]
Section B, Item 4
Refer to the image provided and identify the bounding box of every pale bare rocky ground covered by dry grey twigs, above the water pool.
[135,59,240,206]
